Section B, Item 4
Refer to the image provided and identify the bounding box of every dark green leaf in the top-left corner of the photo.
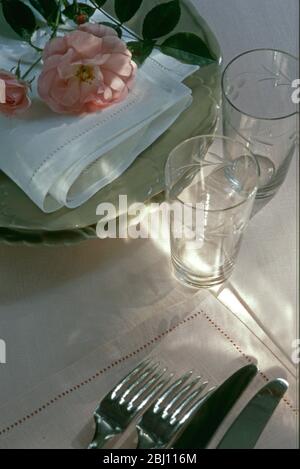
[2,0,37,41]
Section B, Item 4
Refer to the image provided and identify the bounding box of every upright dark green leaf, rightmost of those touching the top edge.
[143,0,181,39]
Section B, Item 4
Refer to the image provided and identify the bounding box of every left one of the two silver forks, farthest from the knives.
[89,360,171,449]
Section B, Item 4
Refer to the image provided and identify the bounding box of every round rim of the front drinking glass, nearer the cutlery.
[165,134,259,213]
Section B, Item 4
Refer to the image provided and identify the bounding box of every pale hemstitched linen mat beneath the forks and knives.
[0,294,298,449]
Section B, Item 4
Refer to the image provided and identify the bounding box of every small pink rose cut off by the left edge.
[0,70,31,116]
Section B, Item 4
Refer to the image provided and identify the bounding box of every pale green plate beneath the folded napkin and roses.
[0,0,221,245]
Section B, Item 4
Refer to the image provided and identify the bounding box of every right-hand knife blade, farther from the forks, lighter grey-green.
[217,379,289,449]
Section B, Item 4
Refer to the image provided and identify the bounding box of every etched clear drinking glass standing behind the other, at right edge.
[222,49,299,199]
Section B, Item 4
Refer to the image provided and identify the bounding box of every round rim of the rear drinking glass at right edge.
[221,47,299,121]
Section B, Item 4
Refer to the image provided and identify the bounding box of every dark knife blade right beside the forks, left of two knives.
[172,364,258,449]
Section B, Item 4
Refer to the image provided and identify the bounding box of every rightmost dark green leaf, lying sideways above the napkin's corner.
[160,33,217,66]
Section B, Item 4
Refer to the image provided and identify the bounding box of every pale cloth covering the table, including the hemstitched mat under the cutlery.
[0,0,298,448]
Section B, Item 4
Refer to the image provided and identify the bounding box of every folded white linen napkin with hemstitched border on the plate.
[0,26,197,213]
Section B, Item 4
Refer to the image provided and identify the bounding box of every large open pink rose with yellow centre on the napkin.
[38,23,137,114]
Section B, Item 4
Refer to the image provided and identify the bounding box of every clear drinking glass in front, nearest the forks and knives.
[166,135,258,287]
